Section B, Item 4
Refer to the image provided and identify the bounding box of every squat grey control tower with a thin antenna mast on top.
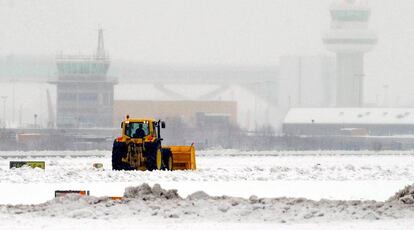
[53,29,116,128]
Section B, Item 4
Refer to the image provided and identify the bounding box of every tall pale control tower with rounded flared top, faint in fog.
[323,0,377,107]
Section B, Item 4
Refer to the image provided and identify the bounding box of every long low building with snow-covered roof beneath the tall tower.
[283,108,414,136]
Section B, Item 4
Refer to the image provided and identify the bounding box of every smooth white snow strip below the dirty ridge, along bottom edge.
[0,217,414,230]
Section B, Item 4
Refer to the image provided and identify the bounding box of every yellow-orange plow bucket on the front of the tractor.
[168,145,196,170]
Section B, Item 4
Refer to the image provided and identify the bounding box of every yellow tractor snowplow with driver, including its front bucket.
[112,116,196,171]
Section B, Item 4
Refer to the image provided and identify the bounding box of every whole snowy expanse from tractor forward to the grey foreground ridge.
[0,150,414,229]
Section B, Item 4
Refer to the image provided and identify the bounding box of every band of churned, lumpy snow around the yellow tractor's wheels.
[0,150,414,183]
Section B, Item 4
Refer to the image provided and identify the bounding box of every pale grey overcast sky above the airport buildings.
[0,0,414,102]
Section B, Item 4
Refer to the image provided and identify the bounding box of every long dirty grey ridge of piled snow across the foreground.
[0,184,414,223]
